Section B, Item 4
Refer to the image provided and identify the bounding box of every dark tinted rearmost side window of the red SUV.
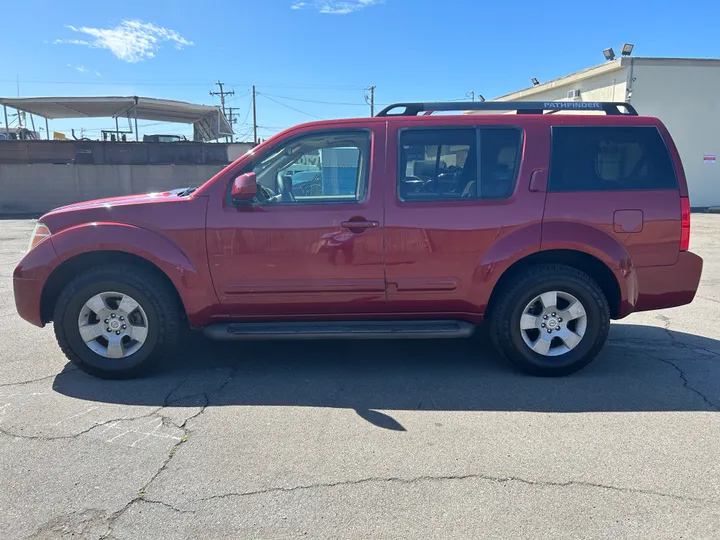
[548,126,677,191]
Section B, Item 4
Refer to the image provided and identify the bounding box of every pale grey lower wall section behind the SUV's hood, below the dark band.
[0,163,224,216]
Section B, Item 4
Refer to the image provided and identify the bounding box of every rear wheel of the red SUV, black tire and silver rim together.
[489,264,610,377]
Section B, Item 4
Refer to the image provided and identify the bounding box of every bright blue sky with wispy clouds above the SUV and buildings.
[0,0,720,139]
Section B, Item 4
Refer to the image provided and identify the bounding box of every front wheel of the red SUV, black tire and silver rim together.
[53,264,182,379]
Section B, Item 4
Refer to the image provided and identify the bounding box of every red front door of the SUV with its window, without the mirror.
[207,126,386,318]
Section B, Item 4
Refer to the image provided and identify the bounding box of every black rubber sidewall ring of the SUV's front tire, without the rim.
[60,279,159,373]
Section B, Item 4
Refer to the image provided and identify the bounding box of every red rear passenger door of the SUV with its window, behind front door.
[385,118,547,314]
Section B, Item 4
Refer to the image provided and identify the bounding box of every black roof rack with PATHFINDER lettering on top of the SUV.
[377,101,637,116]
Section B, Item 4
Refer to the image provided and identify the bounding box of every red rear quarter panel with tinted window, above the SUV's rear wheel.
[543,121,681,266]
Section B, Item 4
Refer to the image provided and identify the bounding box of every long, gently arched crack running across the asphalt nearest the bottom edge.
[192,473,720,505]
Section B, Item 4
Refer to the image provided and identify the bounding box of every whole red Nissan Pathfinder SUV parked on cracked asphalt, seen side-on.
[14,102,702,378]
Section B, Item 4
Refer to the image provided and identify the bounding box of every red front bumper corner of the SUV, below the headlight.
[13,238,60,327]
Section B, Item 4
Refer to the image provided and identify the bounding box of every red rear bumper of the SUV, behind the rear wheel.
[632,251,703,311]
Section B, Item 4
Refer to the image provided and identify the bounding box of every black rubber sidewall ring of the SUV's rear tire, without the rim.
[508,278,607,370]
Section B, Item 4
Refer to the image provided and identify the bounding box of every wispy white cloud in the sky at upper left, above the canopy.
[53,19,193,63]
